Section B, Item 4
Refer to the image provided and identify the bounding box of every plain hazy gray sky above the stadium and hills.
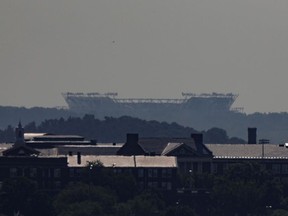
[0,0,288,113]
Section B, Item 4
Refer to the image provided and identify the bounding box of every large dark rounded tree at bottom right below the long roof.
[212,163,281,215]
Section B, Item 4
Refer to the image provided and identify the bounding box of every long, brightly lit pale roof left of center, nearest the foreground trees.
[68,155,177,168]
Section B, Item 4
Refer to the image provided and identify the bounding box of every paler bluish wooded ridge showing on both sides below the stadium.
[0,106,288,143]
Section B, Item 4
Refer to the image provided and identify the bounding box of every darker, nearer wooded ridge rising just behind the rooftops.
[0,115,245,143]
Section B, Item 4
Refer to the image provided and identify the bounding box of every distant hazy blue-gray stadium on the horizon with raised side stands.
[62,92,242,122]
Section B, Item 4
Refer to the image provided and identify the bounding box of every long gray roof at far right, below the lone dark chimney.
[205,144,288,159]
